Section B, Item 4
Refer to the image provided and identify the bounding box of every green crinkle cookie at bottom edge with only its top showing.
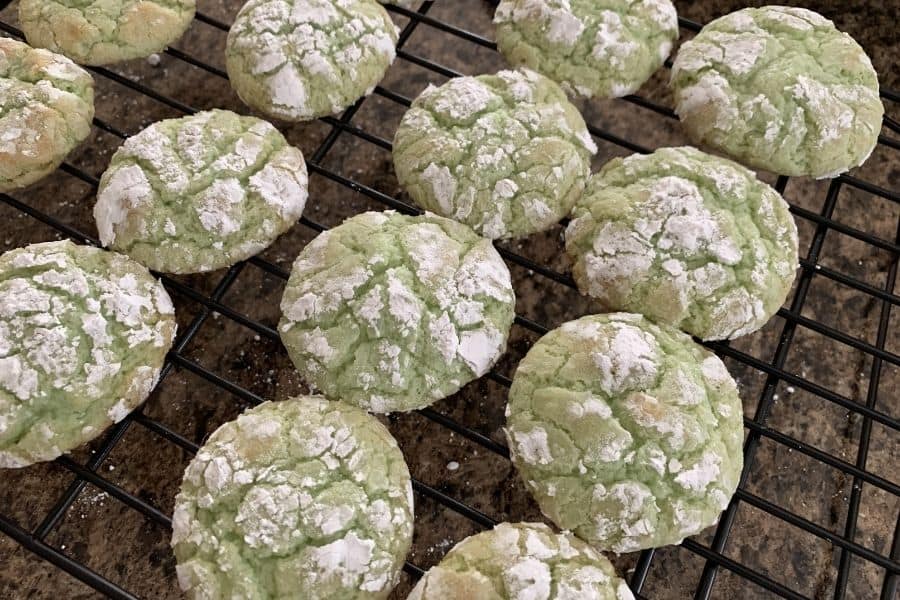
[407,523,634,600]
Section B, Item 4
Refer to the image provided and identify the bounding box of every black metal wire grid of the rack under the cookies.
[0,1,900,600]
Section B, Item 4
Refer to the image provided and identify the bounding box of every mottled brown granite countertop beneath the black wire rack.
[0,0,900,599]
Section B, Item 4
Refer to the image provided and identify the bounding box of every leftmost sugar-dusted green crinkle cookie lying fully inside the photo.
[94,110,307,273]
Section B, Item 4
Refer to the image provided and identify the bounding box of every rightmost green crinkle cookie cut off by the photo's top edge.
[494,0,678,98]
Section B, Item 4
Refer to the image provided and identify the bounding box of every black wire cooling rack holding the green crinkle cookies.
[0,0,900,600]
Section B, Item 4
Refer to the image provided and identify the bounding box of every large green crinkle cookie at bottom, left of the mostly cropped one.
[172,396,413,600]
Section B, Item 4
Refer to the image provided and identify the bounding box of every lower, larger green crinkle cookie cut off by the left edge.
[0,241,176,468]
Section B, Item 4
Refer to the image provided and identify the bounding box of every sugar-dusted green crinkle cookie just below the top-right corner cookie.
[566,147,797,340]
